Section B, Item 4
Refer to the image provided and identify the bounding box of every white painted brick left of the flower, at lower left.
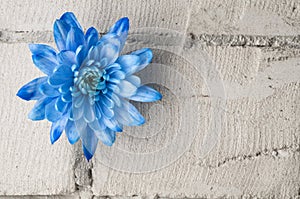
[0,44,75,195]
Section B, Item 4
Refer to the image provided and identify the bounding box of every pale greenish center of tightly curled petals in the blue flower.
[74,65,107,97]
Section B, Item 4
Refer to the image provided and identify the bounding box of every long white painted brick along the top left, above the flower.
[0,0,189,32]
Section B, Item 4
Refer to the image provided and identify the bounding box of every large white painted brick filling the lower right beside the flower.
[92,47,300,198]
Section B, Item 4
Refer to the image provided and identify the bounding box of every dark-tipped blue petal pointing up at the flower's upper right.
[109,17,129,51]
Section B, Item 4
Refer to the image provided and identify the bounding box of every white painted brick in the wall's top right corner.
[188,0,300,36]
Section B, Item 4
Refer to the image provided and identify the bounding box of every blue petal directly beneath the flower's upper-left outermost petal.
[32,54,58,75]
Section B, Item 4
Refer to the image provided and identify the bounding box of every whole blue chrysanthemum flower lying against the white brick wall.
[17,12,162,160]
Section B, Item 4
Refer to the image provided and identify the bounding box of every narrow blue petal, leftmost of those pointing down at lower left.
[50,113,69,144]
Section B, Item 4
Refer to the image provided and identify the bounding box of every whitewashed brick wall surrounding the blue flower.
[0,0,300,199]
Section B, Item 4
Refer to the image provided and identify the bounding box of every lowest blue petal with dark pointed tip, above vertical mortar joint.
[80,126,98,160]
